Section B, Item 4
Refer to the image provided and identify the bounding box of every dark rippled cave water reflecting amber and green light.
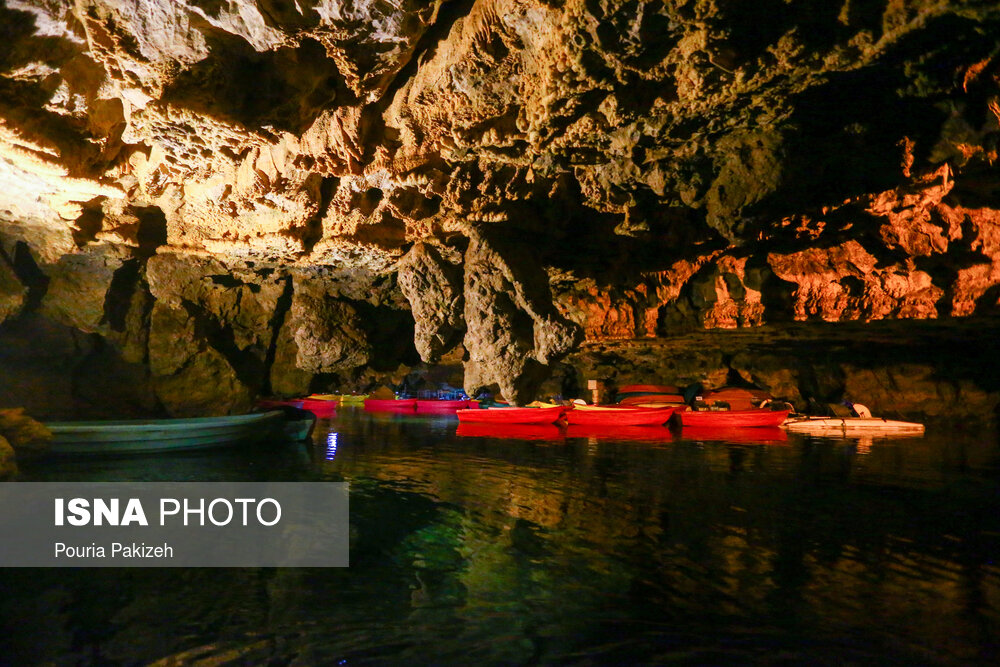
[0,409,1000,665]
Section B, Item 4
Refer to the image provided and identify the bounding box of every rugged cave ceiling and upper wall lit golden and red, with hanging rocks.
[0,0,1000,414]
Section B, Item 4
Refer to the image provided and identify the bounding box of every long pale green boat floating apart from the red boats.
[45,410,284,456]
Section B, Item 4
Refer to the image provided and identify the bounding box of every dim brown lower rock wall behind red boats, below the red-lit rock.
[568,317,1000,428]
